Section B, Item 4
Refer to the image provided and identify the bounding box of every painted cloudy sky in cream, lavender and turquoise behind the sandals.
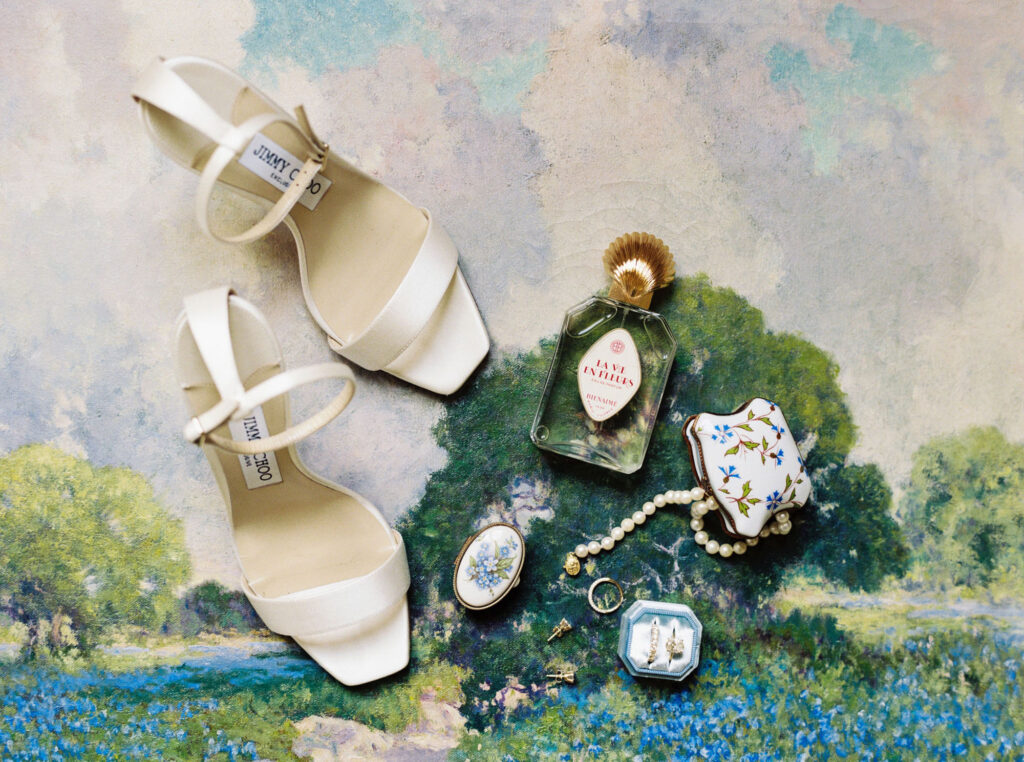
[0,0,1024,581]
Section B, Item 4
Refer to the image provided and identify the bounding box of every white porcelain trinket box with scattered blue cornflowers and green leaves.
[683,397,811,538]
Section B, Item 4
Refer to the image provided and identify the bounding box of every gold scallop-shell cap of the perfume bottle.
[603,232,676,309]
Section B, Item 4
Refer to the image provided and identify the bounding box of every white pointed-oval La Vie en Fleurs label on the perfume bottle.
[577,328,640,422]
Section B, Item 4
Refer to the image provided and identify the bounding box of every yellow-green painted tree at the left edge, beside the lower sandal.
[0,445,189,653]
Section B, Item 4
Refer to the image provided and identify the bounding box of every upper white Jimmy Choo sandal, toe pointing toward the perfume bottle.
[138,56,489,394]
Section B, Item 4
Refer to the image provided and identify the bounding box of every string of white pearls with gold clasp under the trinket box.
[565,486,793,577]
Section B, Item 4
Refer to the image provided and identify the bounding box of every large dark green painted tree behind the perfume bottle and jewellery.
[401,276,906,700]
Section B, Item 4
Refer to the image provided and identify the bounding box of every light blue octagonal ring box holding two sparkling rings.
[618,600,703,681]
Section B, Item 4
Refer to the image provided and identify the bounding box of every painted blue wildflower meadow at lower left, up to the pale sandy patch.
[0,642,465,762]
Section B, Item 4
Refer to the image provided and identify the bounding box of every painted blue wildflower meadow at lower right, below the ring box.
[456,632,1024,762]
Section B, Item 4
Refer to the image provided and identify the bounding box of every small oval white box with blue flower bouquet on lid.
[452,521,526,611]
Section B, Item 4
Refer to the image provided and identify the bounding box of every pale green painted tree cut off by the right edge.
[900,427,1024,594]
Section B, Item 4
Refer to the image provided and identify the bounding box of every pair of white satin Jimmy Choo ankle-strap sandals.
[132,57,489,685]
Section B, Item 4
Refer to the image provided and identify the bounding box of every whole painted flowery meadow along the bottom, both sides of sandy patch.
[0,600,1024,761]
